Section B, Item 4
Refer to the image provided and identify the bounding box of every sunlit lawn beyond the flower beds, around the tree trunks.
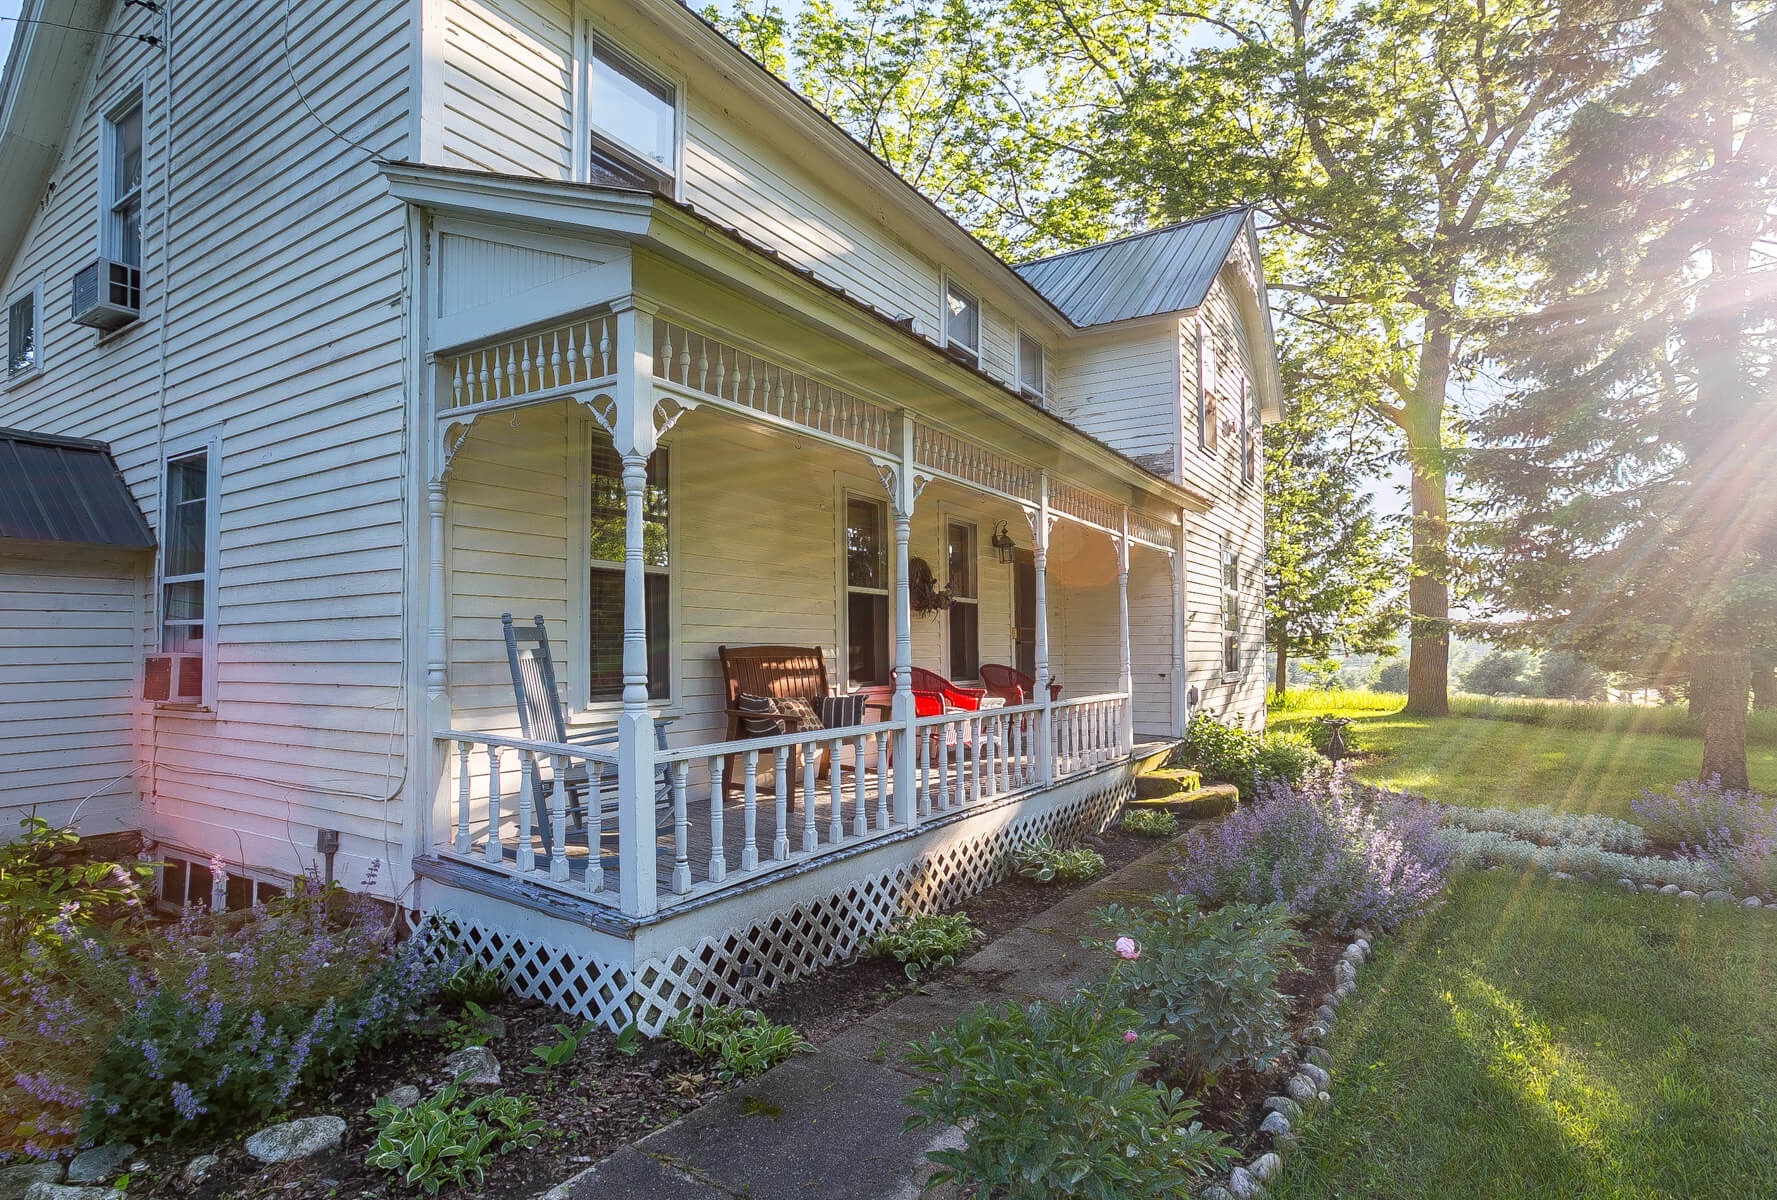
[1271,711,1777,818]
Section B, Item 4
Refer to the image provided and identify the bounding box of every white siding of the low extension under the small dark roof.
[0,546,147,841]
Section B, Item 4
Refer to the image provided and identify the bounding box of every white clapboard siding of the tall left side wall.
[0,0,412,887]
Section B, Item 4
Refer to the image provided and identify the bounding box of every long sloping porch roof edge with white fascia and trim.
[382,162,1215,512]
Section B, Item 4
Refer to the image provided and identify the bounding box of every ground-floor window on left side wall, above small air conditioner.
[160,444,219,704]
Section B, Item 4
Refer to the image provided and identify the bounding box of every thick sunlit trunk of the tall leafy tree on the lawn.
[1400,313,1450,716]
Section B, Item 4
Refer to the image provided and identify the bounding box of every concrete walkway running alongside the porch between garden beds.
[544,843,1173,1200]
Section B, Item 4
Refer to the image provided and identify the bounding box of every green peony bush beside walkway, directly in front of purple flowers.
[1086,896,1303,1092]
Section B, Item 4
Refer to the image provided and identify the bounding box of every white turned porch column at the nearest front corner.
[614,304,659,917]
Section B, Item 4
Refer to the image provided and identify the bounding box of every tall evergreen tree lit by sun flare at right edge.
[1470,0,1777,788]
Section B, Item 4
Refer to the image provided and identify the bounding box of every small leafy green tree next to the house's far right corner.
[1265,343,1404,697]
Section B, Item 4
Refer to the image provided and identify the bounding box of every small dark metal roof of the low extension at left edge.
[0,428,155,549]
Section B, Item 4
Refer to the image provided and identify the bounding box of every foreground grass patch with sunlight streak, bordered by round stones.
[1271,871,1777,1200]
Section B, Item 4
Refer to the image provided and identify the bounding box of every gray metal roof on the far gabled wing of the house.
[1016,208,1249,329]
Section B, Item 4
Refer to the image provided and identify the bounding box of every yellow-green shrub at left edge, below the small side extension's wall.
[0,814,155,983]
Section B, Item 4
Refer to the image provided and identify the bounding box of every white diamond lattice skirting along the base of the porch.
[428,764,1134,1035]
